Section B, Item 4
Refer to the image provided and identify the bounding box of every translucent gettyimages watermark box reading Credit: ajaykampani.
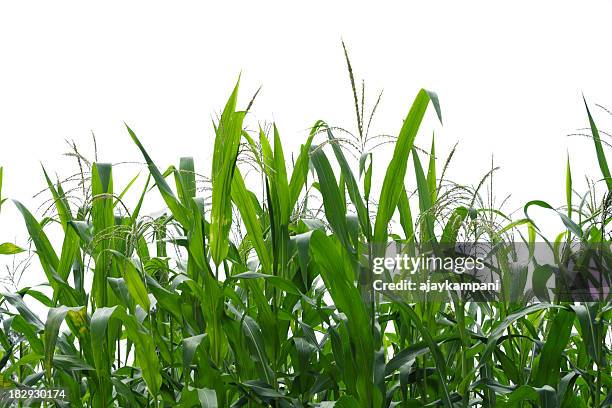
[362,242,611,302]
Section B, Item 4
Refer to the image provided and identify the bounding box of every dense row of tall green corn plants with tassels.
[0,56,612,408]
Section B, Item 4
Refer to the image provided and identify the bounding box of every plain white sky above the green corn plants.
[0,0,612,286]
